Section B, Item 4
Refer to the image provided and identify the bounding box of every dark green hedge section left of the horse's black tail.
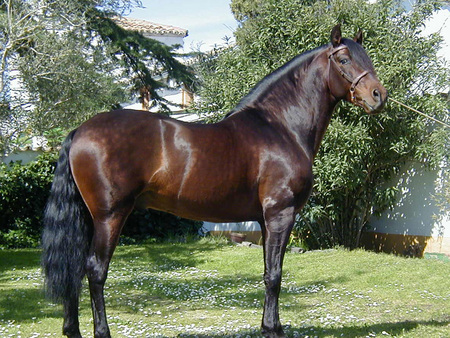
[0,153,56,248]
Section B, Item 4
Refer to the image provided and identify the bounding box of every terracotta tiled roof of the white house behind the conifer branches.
[114,16,188,37]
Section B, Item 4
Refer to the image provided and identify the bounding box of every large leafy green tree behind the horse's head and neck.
[194,0,450,248]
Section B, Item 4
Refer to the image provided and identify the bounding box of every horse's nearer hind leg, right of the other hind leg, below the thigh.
[86,206,132,338]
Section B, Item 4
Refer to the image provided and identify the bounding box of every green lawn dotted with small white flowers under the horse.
[0,240,450,338]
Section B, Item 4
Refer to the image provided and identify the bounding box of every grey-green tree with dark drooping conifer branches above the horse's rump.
[0,0,191,152]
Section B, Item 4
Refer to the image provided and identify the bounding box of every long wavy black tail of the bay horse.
[42,130,90,301]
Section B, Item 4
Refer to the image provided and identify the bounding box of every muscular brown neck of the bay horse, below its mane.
[258,53,338,159]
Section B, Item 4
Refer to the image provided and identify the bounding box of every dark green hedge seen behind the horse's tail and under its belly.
[0,153,202,248]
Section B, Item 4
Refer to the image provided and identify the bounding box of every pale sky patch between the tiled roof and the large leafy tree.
[128,0,237,52]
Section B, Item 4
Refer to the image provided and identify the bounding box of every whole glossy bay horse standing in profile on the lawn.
[42,25,387,337]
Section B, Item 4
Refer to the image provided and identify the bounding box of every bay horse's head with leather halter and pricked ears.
[328,25,388,114]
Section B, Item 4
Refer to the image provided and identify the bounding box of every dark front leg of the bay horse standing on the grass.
[261,209,294,337]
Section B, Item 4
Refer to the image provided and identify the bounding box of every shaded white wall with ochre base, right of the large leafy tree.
[361,164,450,256]
